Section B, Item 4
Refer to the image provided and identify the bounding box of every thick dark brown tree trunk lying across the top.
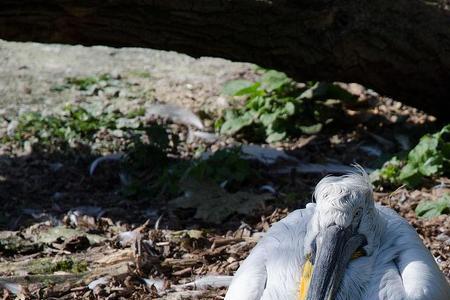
[0,0,450,120]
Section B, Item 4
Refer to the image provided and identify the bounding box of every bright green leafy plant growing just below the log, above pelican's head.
[215,70,354,143]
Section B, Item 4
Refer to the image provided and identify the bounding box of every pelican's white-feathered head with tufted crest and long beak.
[300,171,383,300]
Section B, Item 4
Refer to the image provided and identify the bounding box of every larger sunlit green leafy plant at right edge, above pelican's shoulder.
[375,125,450,187]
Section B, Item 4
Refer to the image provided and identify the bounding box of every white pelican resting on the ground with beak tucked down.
[225,170,450,300]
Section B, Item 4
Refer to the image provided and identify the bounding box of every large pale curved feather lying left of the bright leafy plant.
[146,104,204,130]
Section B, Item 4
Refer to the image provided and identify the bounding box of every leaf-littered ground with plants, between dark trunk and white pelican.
[0,41,450,299]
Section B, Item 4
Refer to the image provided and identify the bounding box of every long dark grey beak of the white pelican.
[302,225,365,300]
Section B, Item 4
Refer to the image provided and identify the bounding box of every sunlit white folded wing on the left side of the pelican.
[225,205,314,300]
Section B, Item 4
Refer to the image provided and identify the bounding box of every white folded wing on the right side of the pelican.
[367,206,450,300]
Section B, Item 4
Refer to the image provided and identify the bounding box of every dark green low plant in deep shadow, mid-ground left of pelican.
[123,139,258,198]
